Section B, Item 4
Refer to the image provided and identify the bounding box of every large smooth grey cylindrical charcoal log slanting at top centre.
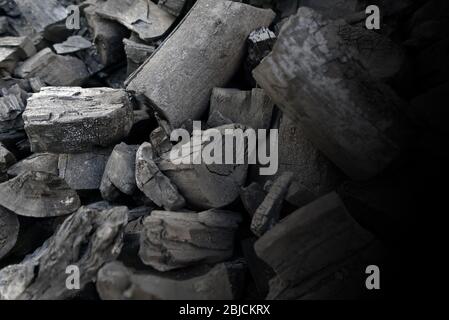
[127,0,274,128]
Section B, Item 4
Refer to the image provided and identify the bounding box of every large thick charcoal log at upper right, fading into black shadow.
[253,7,401,179]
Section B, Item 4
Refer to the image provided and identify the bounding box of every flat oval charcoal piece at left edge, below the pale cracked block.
[0,171,81,217]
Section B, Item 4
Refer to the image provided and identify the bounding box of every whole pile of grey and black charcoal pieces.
[0,0,449,300]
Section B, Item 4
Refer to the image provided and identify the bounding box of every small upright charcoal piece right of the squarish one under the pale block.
[100,143,139,201]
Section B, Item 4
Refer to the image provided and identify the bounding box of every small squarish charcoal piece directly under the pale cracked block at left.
[58,149,111,190]
